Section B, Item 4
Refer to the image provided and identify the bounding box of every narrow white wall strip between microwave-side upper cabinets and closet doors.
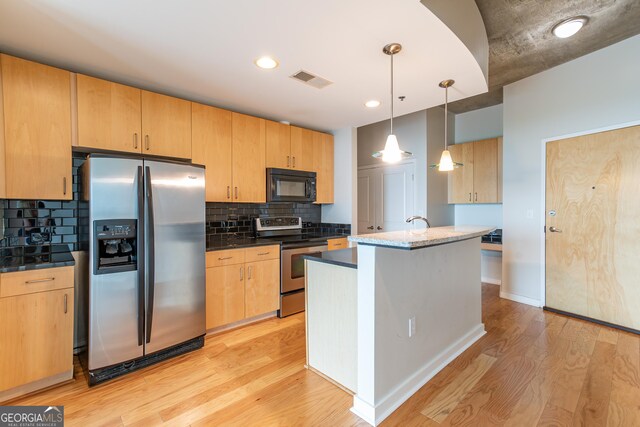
[322,127,358,231]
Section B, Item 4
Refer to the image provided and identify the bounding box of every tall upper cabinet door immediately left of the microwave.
[231,113,267,203]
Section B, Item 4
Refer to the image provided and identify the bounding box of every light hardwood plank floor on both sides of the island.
[6,285,640,426]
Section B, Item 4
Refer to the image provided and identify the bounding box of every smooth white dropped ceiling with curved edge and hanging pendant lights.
[0,0,487,130]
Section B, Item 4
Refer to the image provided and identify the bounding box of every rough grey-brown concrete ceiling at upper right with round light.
[449,0,640,113]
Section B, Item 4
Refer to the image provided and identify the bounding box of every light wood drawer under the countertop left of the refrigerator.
[0,267,73,297]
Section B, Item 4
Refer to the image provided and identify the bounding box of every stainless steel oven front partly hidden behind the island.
[279,242,327,317]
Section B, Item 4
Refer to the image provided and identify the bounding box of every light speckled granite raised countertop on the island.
[349,225,494,249]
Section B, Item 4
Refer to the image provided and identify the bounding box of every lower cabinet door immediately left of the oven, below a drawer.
[245,259,280,318]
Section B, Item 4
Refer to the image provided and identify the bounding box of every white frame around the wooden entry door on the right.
[539,120,640,307]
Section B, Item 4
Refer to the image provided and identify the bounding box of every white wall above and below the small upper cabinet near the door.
[455,104,503,228]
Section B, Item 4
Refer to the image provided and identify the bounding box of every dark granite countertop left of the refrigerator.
[0,245,76,273]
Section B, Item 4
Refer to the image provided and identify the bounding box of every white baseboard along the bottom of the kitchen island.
[351,323,486,426]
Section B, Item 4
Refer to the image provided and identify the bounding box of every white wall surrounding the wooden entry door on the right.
[502,36,640,304]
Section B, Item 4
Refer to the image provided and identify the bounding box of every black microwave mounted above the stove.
[267,168,316,203]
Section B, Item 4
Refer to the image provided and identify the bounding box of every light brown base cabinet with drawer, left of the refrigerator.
[0,267,74,401]
